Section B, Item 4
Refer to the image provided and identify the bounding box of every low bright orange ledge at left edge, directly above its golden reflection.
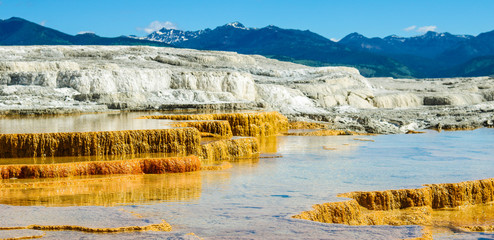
[0,156,201,179]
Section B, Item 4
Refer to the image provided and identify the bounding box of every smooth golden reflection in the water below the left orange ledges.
[0,172,204,207]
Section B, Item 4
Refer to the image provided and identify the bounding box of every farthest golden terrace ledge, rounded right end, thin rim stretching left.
[144,112,288,136]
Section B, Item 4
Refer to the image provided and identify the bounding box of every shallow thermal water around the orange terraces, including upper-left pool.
[0,113,494,239]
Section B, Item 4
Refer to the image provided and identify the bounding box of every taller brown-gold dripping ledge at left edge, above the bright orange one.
[0,128,201,158]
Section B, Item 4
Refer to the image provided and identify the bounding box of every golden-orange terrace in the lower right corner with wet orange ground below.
[293,178,494,239]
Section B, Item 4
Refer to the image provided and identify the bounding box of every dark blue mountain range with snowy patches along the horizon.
[0,18,494,78]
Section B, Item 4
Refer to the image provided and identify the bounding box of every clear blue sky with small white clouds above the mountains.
[0,0,494,39]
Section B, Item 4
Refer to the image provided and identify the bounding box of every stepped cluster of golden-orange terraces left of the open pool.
[0,112,274,179]
